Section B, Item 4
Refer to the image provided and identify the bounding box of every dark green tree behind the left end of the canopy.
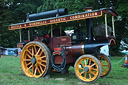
[0,0,43,47]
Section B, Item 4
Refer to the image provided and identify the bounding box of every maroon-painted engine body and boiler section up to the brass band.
[49,36,83,64]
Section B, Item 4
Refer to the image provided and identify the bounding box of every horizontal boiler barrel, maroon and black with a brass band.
[65,42,109,57]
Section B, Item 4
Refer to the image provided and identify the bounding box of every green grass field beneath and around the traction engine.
[0,56,128,85]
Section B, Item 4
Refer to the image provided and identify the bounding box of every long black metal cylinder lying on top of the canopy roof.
[28,8,68,21]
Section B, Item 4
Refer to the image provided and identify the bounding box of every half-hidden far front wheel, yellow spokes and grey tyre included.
[99,54,111,77]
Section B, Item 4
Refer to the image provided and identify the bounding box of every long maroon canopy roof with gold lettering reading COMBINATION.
[9,8,118,30]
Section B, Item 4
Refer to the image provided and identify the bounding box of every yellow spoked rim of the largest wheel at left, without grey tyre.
[21,43,47,78]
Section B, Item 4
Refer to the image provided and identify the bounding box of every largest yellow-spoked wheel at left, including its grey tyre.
[21,41,51,78]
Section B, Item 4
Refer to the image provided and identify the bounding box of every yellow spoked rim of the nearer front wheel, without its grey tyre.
[75,56,99,82]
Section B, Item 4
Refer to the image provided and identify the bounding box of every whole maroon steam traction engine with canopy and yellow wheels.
[9,7,117,83]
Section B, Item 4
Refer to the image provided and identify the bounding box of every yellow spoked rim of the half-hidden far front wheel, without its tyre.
[99,54,110,76]
